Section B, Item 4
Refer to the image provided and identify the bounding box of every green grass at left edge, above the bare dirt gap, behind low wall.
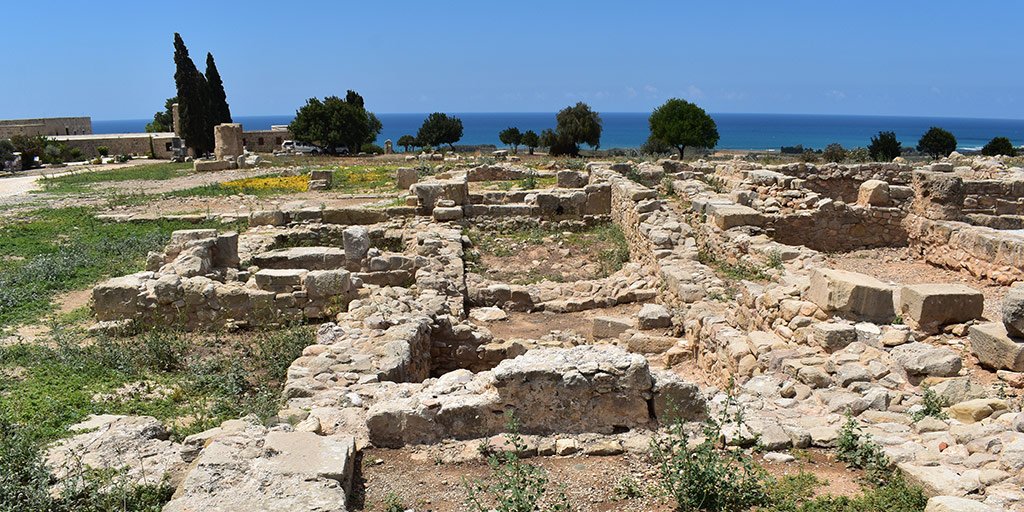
[0,207,238,328]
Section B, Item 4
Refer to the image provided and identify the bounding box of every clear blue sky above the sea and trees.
[0,0,1024,120]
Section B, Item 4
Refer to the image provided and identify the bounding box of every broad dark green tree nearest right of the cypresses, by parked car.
[288,91,382,154]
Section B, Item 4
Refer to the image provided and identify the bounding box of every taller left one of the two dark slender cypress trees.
[174,33,214,155]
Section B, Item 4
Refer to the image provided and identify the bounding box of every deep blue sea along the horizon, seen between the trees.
[92,112,1024,151]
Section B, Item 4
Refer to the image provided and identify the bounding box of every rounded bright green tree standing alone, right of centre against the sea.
[647,98,718,159]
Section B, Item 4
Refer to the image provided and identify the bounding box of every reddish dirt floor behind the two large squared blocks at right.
[827,248,1009,319]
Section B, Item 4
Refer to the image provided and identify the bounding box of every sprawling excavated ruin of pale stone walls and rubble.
[70,155,1024,511]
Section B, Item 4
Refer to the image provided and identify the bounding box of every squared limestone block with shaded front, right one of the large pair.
[899,284,985,333]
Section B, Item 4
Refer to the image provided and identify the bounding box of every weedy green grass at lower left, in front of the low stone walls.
[0,327,314,442]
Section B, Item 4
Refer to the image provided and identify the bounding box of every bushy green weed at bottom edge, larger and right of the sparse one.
[651,395,774,512]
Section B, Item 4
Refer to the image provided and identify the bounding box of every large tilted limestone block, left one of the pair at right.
[807,268,895,324]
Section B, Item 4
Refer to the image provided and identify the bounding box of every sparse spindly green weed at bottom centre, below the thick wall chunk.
[465,414,569,512]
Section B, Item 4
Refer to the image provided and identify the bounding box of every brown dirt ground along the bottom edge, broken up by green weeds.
[353,447,860,512]
